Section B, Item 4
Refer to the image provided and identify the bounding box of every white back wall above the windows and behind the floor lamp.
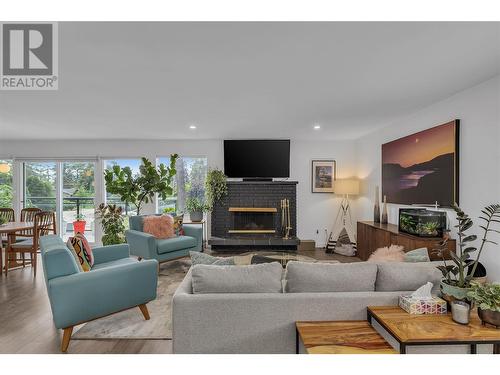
[0,140,356,246]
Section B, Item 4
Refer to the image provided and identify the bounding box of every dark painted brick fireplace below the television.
[208,181,299,250]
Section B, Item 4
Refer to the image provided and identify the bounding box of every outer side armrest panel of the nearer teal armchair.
[47,260,158,328]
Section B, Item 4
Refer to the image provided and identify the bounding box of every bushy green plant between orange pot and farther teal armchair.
[95,203,125,246]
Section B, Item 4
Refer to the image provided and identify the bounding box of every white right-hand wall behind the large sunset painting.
[356,76,500,281]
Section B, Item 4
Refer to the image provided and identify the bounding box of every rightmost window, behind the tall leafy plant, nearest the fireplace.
[158,156,208,213]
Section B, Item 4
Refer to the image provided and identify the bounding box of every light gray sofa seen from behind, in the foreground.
[172,262,441,353]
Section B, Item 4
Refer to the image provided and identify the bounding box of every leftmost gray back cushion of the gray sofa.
[192,262,283,294]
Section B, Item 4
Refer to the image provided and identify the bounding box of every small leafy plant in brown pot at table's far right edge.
[467,284,500,328]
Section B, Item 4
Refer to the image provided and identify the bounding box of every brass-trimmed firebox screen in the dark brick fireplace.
[228,207,277,233]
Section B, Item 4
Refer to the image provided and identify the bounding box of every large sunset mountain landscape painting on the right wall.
[382,120,459,207]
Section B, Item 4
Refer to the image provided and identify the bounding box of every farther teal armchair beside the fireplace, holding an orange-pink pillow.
[125,215,203,263]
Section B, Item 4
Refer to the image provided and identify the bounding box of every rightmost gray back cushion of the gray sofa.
[375,262,442,293]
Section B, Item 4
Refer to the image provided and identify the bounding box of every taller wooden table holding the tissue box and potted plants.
[367,306,500,354]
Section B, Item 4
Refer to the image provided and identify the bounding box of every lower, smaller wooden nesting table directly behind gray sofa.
[295,320,397,354]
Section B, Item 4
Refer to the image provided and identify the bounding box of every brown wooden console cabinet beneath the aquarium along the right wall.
[357,221,456,260]
